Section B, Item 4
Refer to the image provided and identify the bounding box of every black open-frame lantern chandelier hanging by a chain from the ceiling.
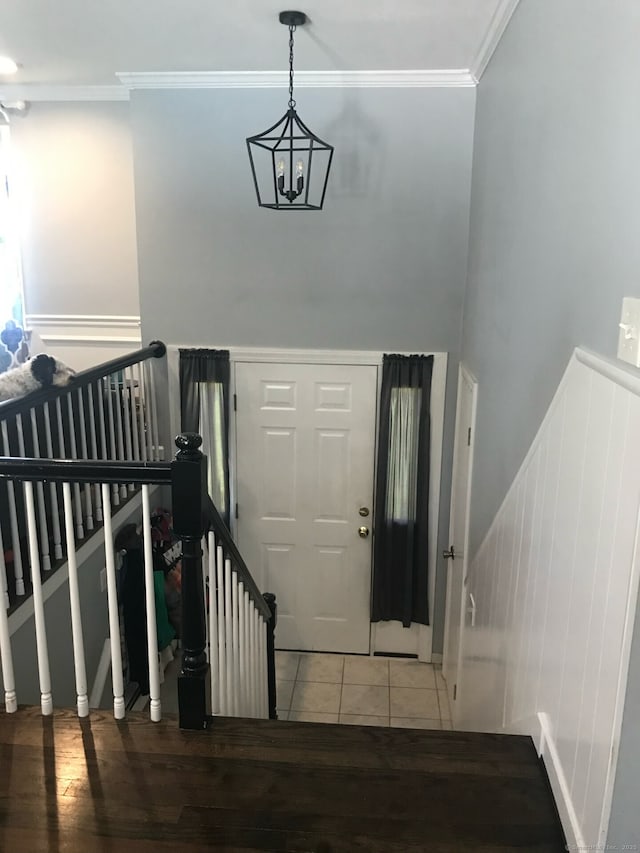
[247,12,333,210]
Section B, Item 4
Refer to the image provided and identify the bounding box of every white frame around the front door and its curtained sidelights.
[167,342,448,661]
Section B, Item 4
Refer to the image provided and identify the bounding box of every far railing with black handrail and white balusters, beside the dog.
[0,342,165,616]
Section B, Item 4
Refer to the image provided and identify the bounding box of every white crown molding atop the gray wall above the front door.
[116,68,476,90]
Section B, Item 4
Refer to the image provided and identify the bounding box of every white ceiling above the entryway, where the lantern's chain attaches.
[0,0,517,97]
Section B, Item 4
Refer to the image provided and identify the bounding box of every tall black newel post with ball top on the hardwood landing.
[171,433,211,729]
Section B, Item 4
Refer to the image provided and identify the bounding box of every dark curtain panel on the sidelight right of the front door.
[371,355,433,628]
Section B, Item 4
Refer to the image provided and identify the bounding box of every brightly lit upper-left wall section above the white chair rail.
[11,102,140,315]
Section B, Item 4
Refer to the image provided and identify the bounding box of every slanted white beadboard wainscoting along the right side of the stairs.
[456,350,640,849]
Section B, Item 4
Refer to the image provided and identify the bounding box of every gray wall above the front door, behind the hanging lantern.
[131,89,475,352]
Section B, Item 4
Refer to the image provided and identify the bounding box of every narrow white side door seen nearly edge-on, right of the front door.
[442,365,477,722]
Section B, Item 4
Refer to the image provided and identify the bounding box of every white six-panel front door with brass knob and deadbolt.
[235,362,377,653]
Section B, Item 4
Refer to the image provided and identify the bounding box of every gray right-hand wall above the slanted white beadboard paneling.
[462,0,640,844]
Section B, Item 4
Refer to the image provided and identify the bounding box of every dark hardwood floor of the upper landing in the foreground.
[0,708,564,853]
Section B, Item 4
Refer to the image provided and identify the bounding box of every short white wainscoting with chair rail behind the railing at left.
[25,314,142,371]
